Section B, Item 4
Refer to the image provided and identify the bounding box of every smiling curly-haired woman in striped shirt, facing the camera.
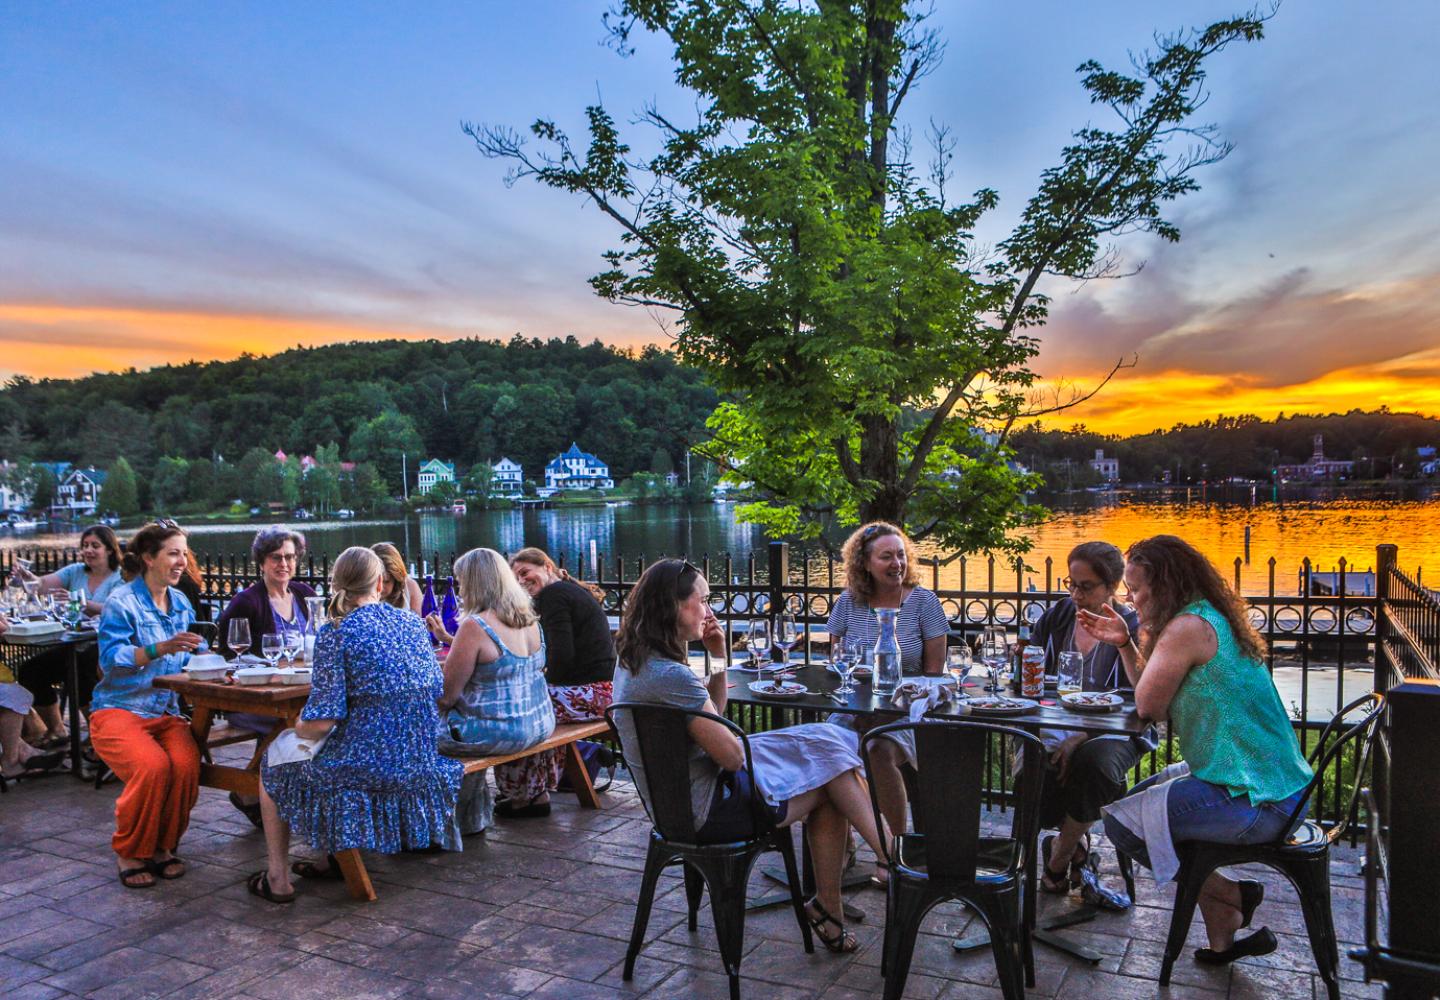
[825,520,950,830]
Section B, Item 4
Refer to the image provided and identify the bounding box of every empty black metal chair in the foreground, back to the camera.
[860,720,1044,1000]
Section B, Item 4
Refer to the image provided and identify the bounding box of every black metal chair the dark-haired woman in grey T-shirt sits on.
[605,702,815,1000]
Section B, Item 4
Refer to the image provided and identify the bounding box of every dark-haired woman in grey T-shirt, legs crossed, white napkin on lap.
[615,559,883,952]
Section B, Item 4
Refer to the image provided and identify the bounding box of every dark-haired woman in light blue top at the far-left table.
[19,524,124,749]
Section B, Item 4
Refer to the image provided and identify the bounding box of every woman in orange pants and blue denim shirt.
[91,522,203,889]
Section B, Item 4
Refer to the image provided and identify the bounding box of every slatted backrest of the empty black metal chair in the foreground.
[860,719,1044,880]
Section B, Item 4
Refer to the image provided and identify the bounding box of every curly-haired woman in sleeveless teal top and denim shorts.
[1077,535,1312,964]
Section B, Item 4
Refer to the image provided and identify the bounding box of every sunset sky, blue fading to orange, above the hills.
[0,0,1440,432]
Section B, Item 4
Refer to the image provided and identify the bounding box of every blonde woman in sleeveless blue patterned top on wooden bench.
[441,549,554,831]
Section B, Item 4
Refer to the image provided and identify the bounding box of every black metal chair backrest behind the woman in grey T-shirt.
[605,702,763,843]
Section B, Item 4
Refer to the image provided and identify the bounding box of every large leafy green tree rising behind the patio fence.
[465,0,1263,550]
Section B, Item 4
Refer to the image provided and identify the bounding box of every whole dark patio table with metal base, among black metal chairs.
[726,664,1151,963]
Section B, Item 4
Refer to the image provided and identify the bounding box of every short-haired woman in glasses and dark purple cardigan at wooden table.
[219,524,315,829]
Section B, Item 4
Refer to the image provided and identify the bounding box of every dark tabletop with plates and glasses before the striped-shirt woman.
[727,664,1151,735]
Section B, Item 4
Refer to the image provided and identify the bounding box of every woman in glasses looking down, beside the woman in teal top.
[1031,542,1155,893]
